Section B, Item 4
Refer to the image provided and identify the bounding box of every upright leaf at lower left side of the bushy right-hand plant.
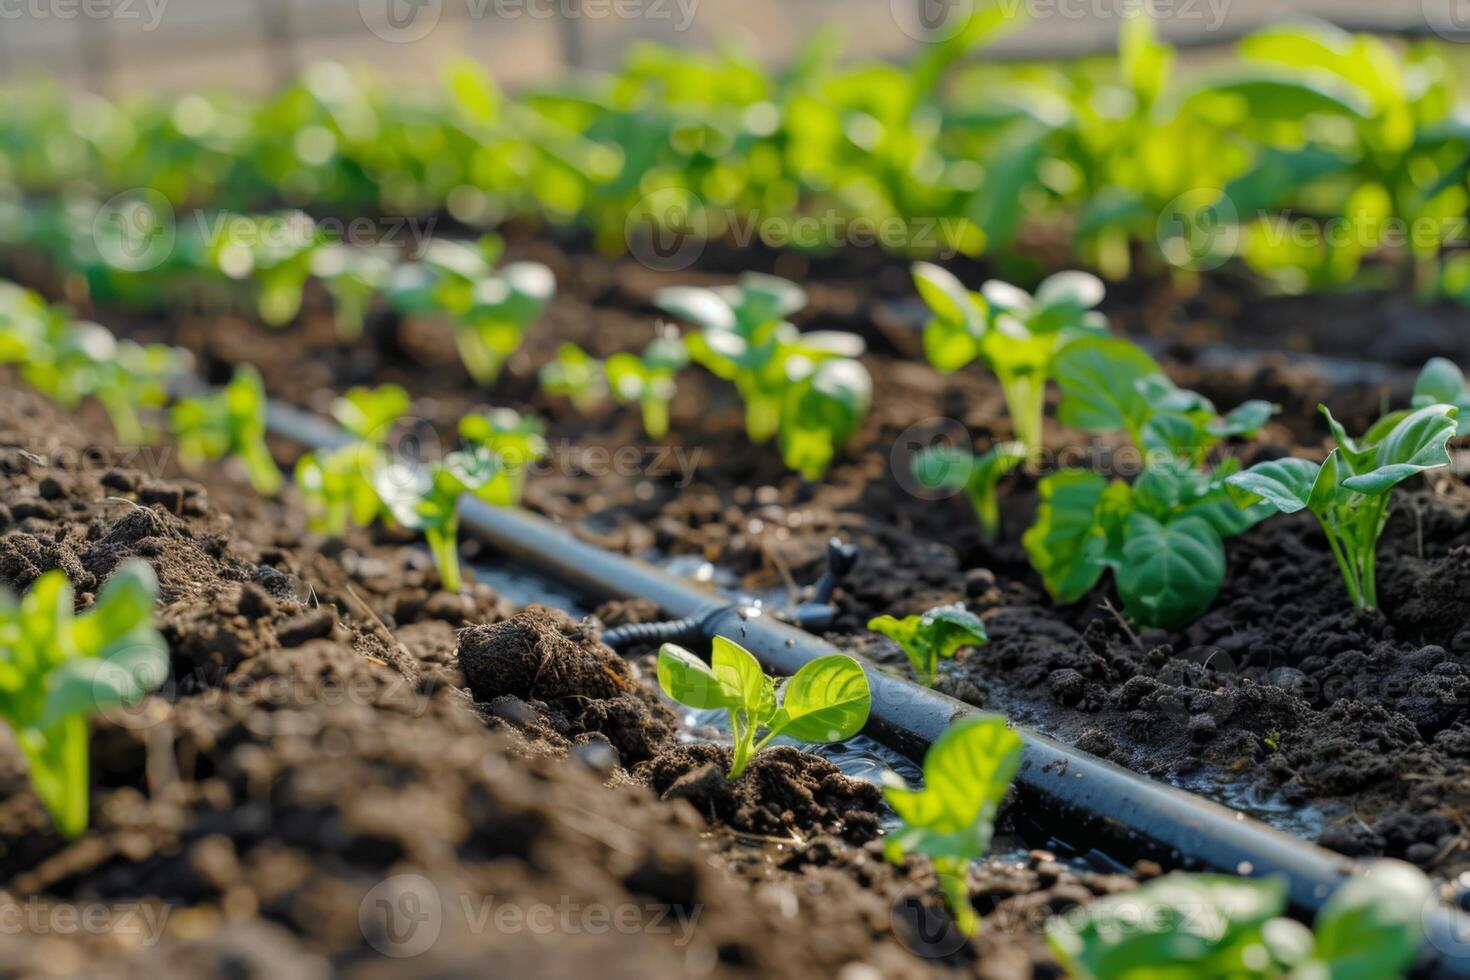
[1022,470,1107,602]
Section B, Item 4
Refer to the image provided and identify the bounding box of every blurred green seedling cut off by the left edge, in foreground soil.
[0,560,169,837]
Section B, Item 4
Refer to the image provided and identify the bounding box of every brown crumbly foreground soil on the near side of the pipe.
[0,376,1133,980]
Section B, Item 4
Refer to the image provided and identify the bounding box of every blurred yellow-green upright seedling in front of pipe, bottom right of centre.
[883,716,1023,936]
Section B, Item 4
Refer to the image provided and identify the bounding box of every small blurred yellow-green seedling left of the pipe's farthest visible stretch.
[173,364,282,497]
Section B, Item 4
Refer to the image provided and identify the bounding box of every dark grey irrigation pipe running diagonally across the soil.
[268,403,1470,979]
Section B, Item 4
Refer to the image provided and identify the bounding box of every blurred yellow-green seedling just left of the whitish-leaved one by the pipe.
[295,385,409,538]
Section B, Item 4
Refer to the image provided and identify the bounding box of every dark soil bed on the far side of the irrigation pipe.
[20,242,1470,880]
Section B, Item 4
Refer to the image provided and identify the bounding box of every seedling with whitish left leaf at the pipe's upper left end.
[373,448,504,592]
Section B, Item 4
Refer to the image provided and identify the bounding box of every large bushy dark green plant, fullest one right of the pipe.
[1022,338,1276,629]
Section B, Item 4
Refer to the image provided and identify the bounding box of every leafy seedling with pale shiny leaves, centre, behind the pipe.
[654,273,872,479]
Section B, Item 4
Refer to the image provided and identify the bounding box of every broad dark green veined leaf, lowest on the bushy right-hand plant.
[1116,513,1225,629]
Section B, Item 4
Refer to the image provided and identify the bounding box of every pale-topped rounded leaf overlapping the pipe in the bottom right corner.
[1314,861,1435,980]
